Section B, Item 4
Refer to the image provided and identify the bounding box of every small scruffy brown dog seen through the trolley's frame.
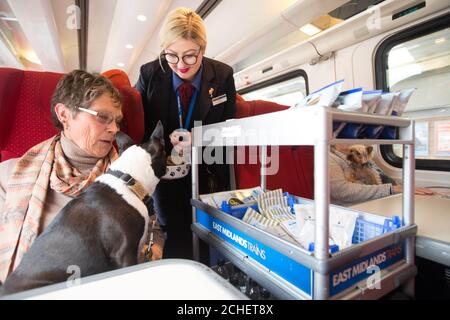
[345,144,382,184]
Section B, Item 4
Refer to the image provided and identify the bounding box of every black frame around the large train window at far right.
[375,13,450,171]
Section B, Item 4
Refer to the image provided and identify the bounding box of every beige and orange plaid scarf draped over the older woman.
[0,135,118,282]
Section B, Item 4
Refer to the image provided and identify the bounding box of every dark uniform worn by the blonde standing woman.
[136,57,236,258]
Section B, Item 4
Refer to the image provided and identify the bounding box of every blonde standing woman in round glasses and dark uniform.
[136,8,236,259]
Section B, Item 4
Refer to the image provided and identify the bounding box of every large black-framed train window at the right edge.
[376,15,450,171]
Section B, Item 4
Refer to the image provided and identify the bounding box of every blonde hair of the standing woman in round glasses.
[159,7,207,51]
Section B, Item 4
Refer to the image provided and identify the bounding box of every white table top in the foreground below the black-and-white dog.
[1,259,248,300]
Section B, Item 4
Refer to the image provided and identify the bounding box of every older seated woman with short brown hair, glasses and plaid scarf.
[0,70,164,282]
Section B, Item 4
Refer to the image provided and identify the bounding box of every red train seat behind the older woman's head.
[0,68,144,162]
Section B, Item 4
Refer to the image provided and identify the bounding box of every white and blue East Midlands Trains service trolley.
[191,107,417,299]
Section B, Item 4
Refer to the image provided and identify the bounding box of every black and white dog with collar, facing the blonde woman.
[0,122,166,295]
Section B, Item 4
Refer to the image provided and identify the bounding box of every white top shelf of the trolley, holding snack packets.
[193,107,414,147]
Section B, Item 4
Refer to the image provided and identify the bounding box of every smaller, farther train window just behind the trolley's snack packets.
[239,70,309,106]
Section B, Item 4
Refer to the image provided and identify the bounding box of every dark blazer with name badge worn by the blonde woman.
[136,57,236,192]
